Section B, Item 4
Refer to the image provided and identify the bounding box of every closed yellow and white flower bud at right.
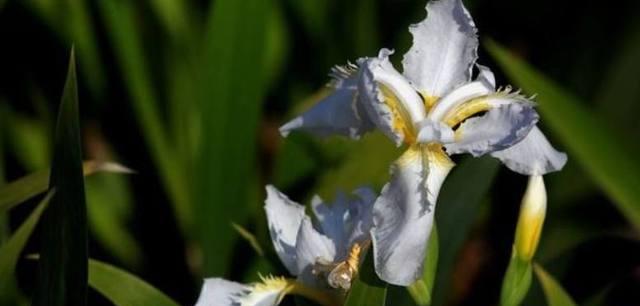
[515,175,547,261]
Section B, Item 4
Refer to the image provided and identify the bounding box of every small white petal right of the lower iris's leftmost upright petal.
[296,217,336,286]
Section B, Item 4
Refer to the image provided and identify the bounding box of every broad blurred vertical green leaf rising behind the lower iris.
[194,0,271,275]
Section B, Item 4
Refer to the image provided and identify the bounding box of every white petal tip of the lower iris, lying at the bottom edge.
[196,278,251,306]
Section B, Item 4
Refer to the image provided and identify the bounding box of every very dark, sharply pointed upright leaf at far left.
[33,49,88,306]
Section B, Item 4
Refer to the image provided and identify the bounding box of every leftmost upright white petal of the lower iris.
[264,185,305,275]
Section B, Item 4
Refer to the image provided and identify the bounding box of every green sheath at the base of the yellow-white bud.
[500,248,531,306]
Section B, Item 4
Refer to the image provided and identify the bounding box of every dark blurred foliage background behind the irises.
[0,0,640,306]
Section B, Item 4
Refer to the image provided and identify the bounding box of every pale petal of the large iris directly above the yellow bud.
[491,126,567,175]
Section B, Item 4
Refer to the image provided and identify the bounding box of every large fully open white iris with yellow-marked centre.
[280,0,566,286]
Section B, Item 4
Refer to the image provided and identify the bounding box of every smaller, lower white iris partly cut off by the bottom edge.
[196,186,376,306]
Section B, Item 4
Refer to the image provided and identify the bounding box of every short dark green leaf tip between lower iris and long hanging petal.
[344,252,387,306]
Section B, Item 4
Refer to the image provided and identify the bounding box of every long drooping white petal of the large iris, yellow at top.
[371,145,453,286]
